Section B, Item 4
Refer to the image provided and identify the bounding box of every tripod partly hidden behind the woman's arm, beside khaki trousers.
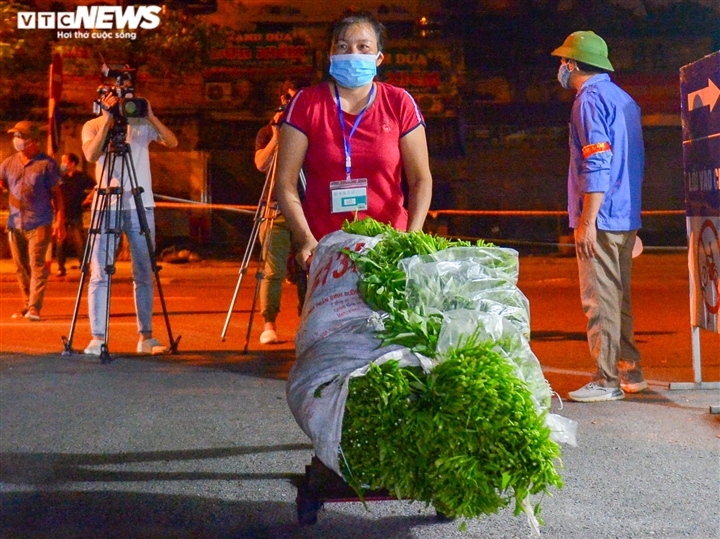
[221,149,290,354]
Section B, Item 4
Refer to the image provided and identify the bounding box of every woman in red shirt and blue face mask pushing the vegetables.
[276,13,432,267]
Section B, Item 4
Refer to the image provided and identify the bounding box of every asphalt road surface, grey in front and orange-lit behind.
[0,254,720,539]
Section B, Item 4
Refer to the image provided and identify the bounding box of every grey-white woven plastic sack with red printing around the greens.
[286,231,418,475]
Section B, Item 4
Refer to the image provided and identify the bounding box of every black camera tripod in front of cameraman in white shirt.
[62,117,180,363]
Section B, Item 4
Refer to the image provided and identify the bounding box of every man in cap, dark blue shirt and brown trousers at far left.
[0,121,65,321]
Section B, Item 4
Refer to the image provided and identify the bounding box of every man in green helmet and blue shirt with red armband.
[552,31,647,402]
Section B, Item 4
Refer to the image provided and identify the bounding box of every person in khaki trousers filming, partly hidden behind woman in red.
[255,81,307,344]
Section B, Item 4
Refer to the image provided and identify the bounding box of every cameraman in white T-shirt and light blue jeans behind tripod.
[82,86,178,356]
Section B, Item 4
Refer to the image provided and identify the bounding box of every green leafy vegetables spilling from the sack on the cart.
[341,219,562,518]
